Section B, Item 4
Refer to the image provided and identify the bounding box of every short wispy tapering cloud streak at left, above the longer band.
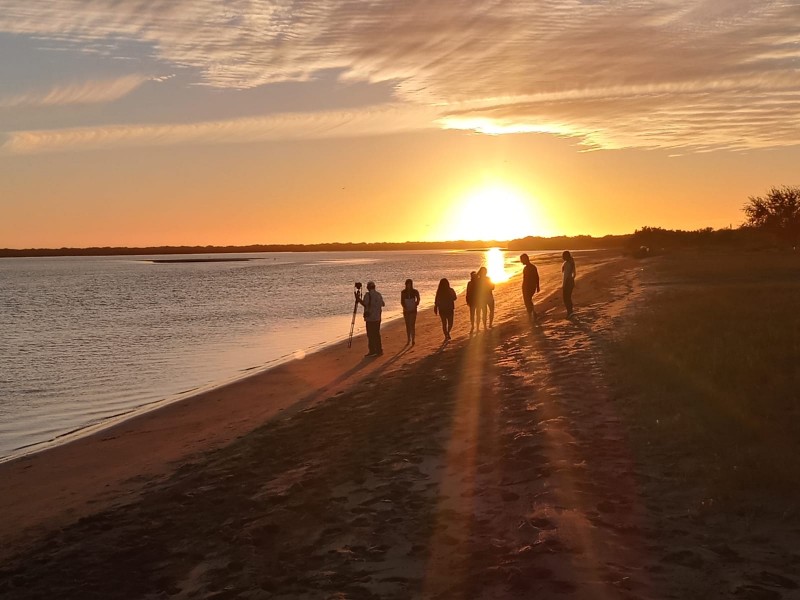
[0,75,148,108]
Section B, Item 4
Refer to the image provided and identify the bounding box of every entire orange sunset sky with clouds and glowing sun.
[0,0,800,248]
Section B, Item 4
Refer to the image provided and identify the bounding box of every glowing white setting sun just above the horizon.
[451,184,537,241]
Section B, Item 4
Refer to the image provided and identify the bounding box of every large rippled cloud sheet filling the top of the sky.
[0,0,800,150]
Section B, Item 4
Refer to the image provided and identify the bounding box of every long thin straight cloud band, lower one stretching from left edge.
[0,106,435,154]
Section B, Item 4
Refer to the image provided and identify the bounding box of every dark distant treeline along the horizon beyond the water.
[0,227,779,258]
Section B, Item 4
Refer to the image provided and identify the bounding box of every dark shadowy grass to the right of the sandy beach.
[611,252,800,502]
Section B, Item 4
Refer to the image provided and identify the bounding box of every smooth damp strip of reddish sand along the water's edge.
[0,251,600,554]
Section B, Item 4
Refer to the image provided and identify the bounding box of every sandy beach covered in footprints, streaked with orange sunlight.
[0,247,797,599]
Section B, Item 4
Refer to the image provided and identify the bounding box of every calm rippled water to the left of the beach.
[0,251,532,457]
